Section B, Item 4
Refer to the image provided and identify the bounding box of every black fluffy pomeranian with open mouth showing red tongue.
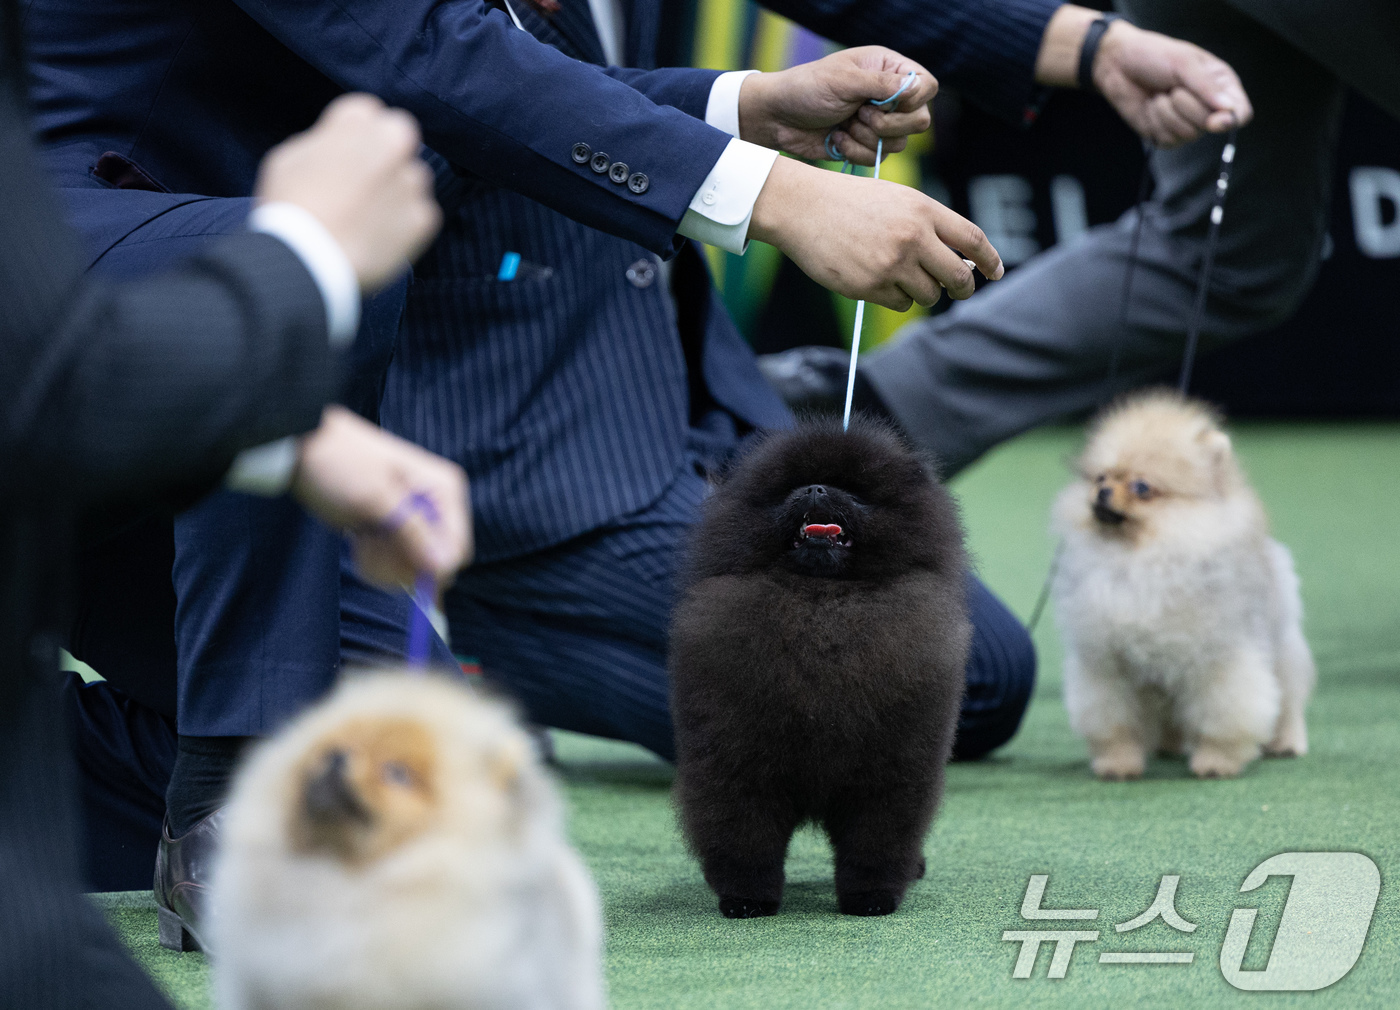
[671,417,972,919]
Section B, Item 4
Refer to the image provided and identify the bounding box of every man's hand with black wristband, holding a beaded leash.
[1036,4,1254,147]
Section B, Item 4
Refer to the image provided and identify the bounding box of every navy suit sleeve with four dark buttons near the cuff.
[237,0,729,254]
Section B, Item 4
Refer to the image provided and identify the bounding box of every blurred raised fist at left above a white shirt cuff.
[253,94,442,291]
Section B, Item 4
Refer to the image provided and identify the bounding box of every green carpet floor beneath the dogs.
[99,424,1400,1010]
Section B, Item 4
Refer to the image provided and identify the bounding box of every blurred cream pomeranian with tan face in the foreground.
[210,672,603,1010]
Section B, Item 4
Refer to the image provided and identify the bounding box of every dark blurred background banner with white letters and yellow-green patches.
[690,0,1400,416]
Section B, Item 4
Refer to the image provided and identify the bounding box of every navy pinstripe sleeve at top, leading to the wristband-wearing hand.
[760,0,1061,122]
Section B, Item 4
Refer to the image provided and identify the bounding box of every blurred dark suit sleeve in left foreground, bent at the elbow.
[0,54,339,496]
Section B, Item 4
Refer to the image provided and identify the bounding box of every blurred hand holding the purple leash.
[291,406,472,587]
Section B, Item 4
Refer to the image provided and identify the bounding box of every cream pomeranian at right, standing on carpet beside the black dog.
[1053,391,1315,779]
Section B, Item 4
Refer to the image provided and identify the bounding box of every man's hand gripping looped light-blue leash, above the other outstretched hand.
[739,46,938,165]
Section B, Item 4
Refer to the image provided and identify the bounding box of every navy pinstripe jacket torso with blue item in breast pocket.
[381,0,1050,562]
